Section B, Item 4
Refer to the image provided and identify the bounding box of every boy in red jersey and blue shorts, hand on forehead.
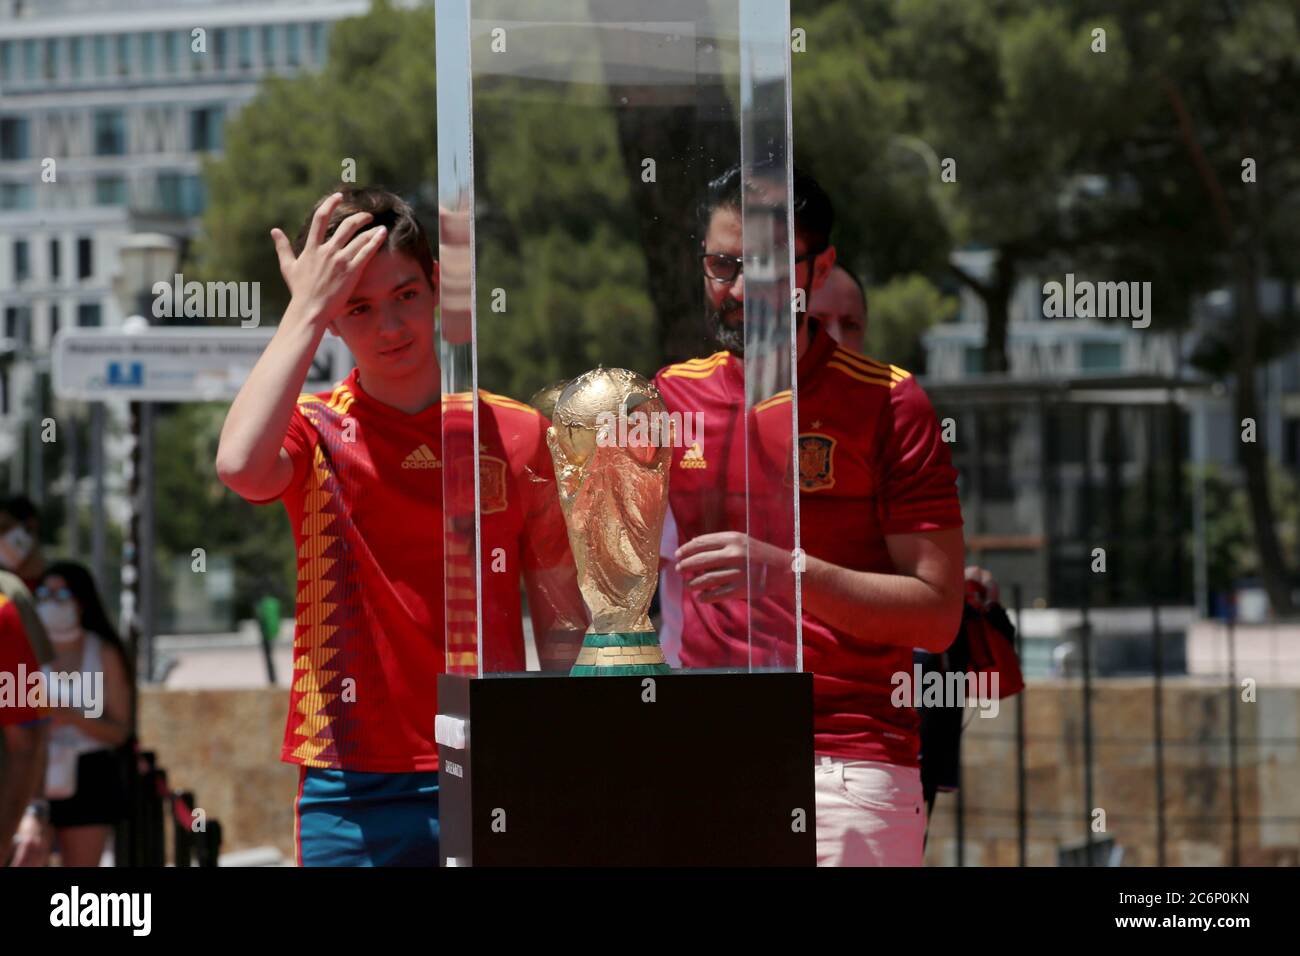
[217,189,585,866]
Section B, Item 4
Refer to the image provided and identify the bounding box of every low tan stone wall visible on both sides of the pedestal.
[140,679,1300,866]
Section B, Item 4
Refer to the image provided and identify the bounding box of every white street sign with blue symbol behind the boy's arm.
[51,326,352,402]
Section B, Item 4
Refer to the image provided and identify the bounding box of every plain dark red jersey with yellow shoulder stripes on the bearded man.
[655,332,962,766]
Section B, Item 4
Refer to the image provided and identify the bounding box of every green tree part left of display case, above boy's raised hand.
[192,0,437,315]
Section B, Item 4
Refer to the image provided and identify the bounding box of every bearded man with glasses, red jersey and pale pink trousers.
[655,169,963,865]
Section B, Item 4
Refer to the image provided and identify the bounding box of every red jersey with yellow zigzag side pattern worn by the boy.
[248,369,572,773]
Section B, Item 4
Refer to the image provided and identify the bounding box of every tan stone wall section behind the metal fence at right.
[926,678,1300,866]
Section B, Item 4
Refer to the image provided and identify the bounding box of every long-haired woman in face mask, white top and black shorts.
[35,562,131,866]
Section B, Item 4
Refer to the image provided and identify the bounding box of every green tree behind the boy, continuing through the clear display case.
[196,1,662,399]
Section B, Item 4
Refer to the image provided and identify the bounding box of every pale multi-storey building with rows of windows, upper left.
[0,0,369,468]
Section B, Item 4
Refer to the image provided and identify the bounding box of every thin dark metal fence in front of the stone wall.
[931,585,1300,866]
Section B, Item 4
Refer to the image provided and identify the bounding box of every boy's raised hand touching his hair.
[270,193,387,323]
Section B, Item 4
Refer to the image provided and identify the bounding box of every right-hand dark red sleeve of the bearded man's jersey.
[876,377,962,535]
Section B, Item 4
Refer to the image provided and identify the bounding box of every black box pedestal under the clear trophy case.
[438,672,816,866]
